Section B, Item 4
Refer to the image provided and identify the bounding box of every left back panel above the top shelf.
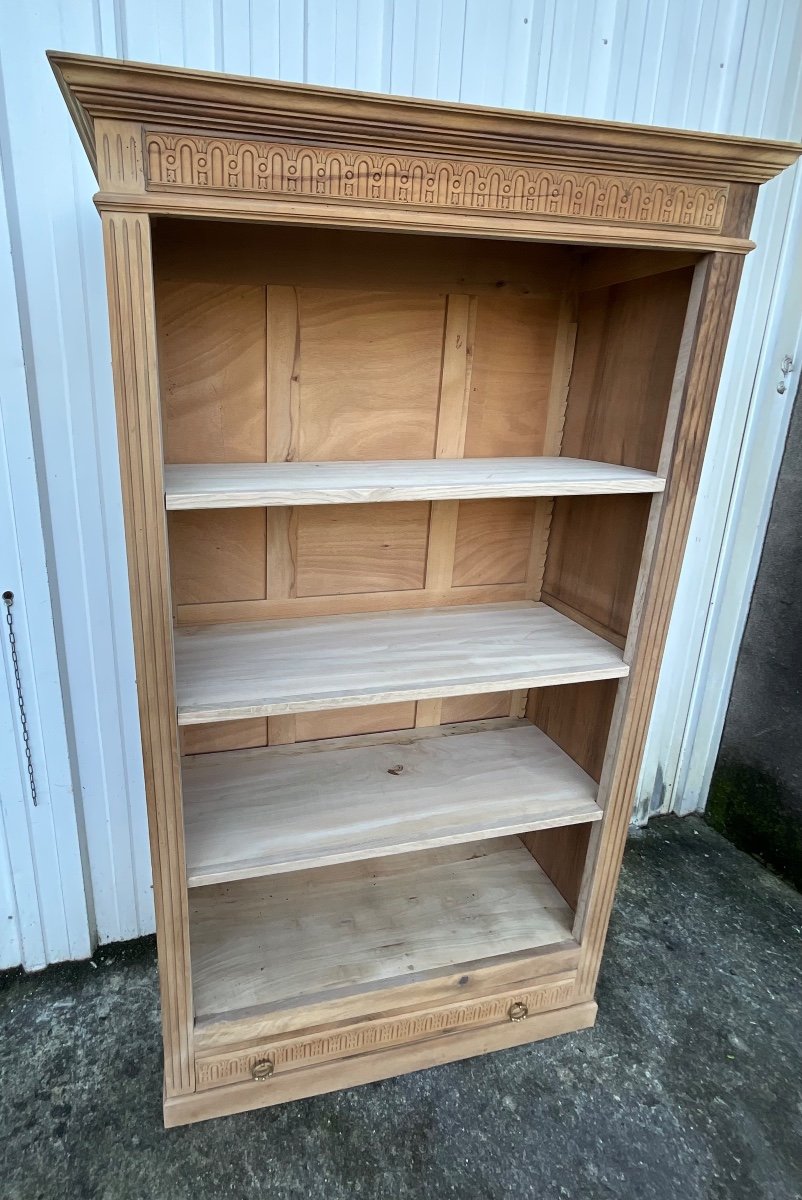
[157,281,267,462]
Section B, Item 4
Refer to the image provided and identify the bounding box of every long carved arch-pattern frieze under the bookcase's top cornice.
[145,132,729,232]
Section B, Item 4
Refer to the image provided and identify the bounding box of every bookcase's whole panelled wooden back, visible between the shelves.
[154,221,573,752]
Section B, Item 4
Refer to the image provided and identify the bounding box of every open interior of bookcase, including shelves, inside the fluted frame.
[154,220,694,1031]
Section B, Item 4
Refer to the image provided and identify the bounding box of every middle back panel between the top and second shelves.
[295,503,430,596]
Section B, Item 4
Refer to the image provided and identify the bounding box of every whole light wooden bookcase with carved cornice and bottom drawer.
[50,54,797,1124]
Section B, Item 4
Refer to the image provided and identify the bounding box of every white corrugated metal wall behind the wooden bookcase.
[0,0,802,967]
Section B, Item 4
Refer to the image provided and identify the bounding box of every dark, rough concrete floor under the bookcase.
[0,818,802,1200]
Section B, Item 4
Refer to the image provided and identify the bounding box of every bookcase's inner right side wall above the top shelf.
[562,268,693,470]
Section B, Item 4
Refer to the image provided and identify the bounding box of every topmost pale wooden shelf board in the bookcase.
[164,458,665,509]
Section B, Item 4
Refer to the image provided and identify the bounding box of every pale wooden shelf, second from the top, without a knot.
[175,601,629,725]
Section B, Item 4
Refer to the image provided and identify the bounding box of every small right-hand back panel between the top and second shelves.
[453,499,534,587]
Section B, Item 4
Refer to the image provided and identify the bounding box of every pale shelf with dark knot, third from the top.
[184,718,602,887]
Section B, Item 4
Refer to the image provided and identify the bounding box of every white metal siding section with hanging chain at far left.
[0,136,90,970]
